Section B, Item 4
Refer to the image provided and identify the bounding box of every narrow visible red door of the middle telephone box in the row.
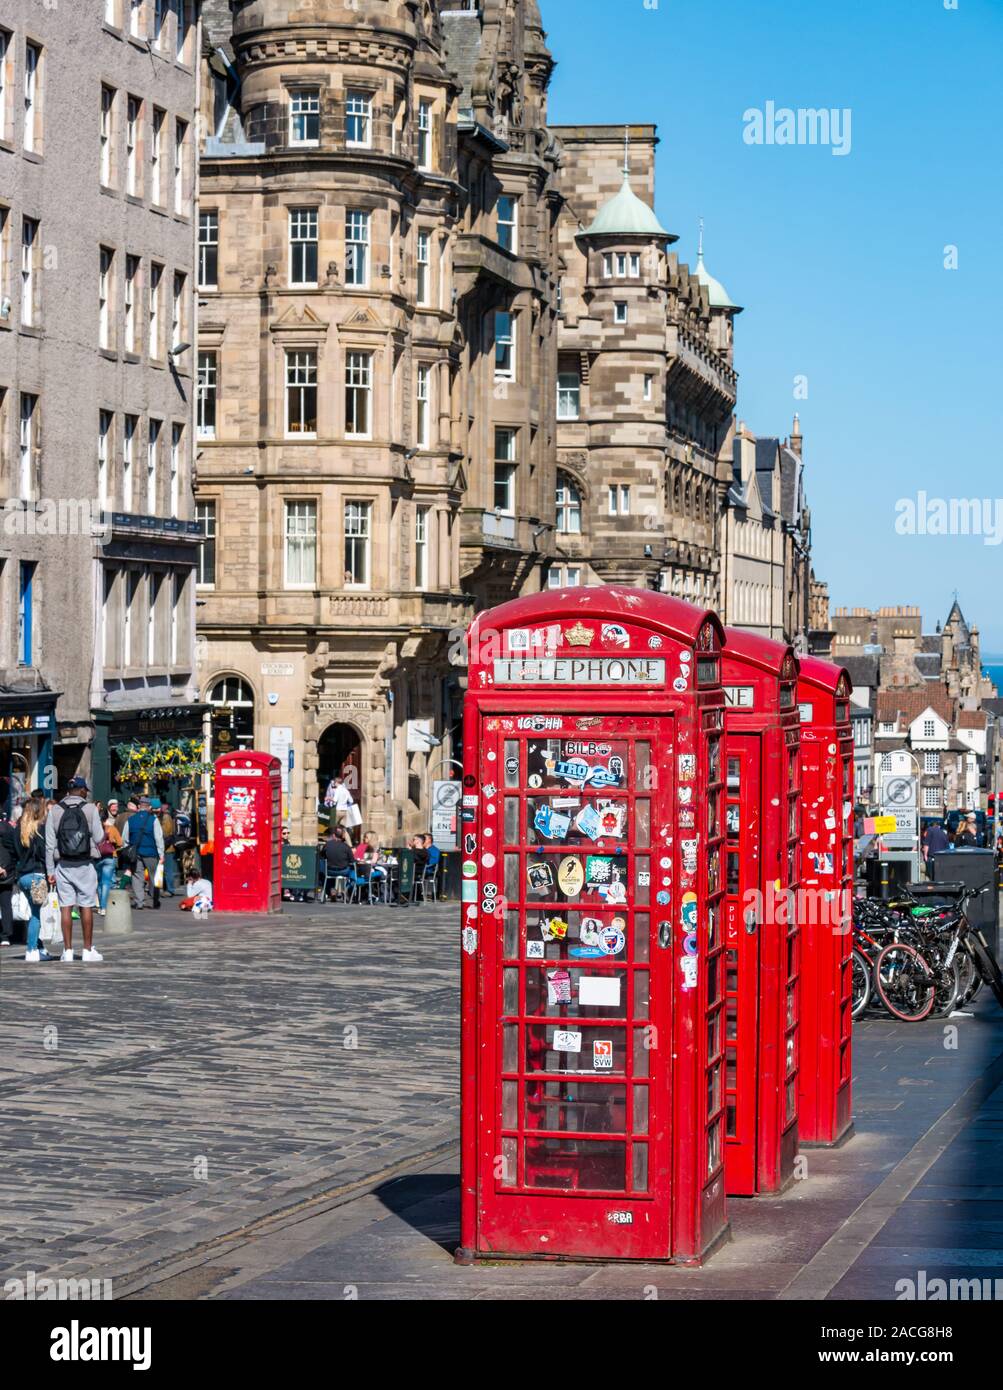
[725,734,763,1194]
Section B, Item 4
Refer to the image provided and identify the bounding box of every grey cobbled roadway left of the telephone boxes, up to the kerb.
[0,902,458,1283]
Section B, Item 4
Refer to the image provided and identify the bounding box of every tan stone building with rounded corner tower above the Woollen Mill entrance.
[197,0,560,838]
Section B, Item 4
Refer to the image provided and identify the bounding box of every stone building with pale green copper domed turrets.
[549,125,740,605]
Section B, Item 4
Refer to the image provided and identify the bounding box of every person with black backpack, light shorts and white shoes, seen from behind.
[46,777,104,962]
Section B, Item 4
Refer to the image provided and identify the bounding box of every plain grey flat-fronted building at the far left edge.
[0,0,201,806]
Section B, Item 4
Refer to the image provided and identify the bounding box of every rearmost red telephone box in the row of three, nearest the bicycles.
[797,656,853,1144]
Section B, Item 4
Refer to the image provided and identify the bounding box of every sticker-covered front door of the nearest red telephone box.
[475,714,675,1259]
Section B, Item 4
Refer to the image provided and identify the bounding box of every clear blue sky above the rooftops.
[540,0,1003,653]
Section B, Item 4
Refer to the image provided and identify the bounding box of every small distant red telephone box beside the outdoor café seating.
[213,751,282,912]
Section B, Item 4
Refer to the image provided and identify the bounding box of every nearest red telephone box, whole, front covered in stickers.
[457,587,727,1262]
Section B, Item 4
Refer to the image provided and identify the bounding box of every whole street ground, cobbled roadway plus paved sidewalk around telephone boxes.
[0,906,1003,1300]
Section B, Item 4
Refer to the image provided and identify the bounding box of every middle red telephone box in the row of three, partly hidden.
[721,627,799,1197]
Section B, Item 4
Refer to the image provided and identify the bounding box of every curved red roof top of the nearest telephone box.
[467,584,724,646]
